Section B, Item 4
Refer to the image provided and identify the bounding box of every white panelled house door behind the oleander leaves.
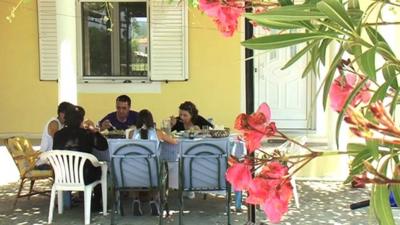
[254,28,313,129]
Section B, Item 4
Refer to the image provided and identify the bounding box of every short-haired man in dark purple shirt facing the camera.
[99,95,138,131]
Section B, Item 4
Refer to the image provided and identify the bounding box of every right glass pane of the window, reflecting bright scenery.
[119,2,149,77]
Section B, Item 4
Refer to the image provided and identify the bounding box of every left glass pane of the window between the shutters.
[82,2,112,76]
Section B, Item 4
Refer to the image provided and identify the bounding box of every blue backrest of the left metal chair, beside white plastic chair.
[109,140,160,189]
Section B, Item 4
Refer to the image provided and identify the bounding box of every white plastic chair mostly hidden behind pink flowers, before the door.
[278,136,307,208]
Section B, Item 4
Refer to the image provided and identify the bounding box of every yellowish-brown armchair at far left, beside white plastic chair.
[4,137,53,209]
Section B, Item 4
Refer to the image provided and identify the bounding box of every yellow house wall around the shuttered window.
[0,1,240,134]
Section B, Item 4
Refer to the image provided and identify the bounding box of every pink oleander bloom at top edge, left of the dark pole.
[199,0,244,37]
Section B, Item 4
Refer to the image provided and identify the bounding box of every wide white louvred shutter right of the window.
[150,0,188,81]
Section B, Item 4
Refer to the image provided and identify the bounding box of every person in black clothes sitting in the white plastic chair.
[53,106,108,211]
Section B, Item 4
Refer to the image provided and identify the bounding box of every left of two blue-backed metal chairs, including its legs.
[109,140,168,224]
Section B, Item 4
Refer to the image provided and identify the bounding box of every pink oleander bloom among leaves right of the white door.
[329,73,371,112]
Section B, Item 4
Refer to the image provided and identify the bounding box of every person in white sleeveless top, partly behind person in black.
[36,102,73,169]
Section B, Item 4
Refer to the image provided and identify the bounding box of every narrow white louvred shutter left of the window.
[37,0,58,80]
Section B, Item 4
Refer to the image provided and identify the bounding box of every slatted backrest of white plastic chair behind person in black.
[41,150,98,186]
